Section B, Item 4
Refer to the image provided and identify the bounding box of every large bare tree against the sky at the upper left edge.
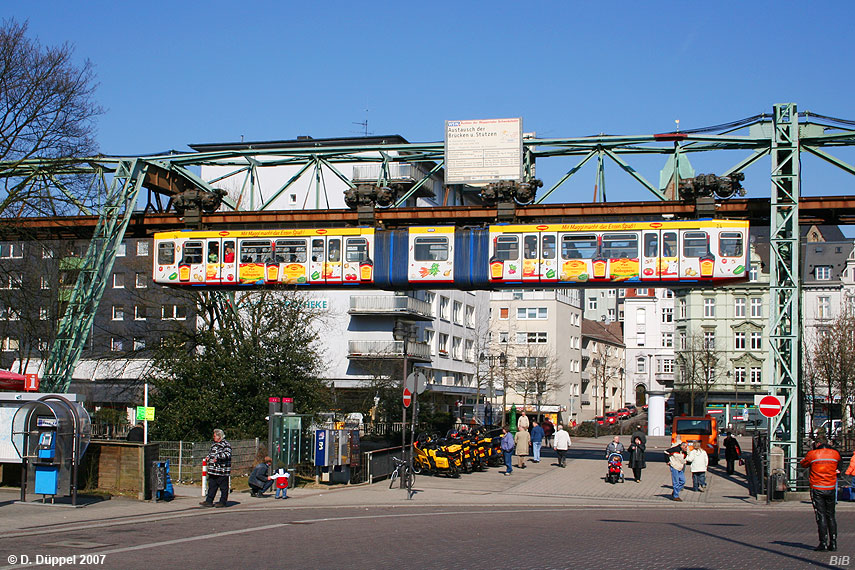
[0,19,102,218]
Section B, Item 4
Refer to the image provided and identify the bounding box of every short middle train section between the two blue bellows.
[407,228,454,283]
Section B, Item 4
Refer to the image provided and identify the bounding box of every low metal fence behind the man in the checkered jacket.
[154,438,267,483]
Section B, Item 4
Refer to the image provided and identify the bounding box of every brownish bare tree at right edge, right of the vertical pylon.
[809,305,855,429]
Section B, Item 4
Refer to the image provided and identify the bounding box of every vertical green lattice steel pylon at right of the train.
[769,103,801,466]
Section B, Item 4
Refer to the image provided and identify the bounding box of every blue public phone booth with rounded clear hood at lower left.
[12,394,92,506]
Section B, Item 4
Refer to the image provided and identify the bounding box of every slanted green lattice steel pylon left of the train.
[41,158,146,393]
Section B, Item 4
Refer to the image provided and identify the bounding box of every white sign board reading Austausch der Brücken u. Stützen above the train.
[445,117,523,184]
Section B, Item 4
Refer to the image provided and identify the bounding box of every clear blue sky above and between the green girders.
[4,1,855,202]
